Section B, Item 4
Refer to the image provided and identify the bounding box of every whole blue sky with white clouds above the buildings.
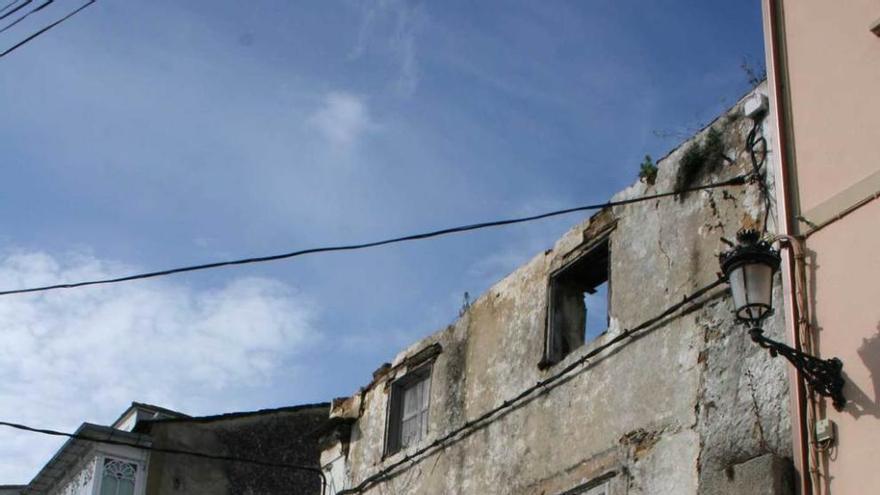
[0,0,763,483]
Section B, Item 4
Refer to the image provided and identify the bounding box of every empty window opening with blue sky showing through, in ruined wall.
[542,238,611,366]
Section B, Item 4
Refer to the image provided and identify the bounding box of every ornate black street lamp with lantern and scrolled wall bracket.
[721,230,846,411]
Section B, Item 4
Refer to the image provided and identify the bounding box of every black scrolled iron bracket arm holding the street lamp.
[749,328,846,411]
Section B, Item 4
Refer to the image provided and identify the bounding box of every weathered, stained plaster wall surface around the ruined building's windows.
[324,87,790,495]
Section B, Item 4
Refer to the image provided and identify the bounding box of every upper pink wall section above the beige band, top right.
[782,0,880,211]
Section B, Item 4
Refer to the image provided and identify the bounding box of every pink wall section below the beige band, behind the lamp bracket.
[807,201,880,494]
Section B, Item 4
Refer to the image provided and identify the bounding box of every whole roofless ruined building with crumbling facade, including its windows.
[321,87,792,495]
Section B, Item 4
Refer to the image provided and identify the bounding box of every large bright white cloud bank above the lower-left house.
[0,252,320,483]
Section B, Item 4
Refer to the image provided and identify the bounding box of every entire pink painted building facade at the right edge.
[764,0,880,495]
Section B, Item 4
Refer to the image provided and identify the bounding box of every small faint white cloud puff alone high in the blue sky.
[309,92,372,148]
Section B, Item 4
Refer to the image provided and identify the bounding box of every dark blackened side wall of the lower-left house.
[147,404,329,495]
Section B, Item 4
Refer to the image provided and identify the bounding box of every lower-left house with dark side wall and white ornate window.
[18,402,329,495]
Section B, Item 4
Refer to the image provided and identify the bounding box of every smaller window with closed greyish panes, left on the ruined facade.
[385,366,431,455]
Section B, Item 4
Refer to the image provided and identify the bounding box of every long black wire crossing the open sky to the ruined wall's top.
[0,174,753,296]
